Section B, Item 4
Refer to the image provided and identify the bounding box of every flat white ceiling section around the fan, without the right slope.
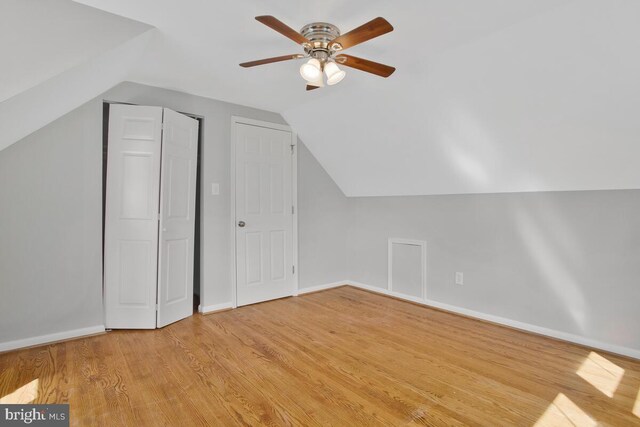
[77,0,567,112]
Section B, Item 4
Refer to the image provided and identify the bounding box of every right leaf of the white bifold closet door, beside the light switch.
[158,108,198,327]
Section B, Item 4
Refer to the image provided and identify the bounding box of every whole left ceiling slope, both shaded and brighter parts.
[0,0,152,150]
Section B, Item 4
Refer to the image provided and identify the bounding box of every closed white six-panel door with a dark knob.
[234,123,294,305]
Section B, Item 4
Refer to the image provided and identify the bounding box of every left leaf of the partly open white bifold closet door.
[104,105,162,329]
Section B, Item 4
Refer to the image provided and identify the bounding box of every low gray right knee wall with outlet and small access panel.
[349,190,640,349]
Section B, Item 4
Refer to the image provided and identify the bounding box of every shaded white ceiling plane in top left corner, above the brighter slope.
[0,0,149,102]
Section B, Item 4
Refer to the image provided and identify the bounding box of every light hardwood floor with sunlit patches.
[0,287,640,426]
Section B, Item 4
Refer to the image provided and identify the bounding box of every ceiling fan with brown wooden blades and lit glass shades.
[240,15,396,90]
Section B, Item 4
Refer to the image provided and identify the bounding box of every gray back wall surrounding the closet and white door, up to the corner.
[0,83,346,342]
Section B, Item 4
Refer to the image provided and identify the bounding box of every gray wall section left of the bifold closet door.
[0,98,104,342]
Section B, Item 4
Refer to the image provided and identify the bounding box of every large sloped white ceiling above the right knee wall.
[284,0,640,196]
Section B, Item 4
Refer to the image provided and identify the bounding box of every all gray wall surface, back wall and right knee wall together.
[0,79,640,349]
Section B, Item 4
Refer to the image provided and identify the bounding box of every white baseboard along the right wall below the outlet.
[345,280,640,359]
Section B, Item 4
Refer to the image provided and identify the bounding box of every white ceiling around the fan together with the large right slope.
[31,0,640,196]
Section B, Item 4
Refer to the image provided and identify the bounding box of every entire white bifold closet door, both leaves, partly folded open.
[104,105,198,329]
